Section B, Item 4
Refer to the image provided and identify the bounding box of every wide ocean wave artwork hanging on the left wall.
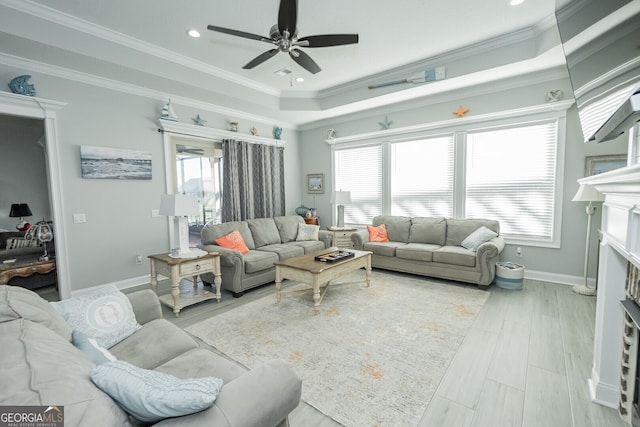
[80,145,151,179]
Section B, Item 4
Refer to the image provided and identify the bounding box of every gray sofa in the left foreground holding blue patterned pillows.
[0,286,301,427]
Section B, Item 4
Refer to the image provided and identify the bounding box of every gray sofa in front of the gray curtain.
[198,215,333,297]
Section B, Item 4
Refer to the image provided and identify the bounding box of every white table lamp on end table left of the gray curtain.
[160,194,202,258]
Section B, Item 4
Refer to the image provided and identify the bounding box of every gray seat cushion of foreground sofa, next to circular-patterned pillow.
[109,319,198,369]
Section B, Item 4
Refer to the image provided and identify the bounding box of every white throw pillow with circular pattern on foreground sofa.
[51,285,140,348]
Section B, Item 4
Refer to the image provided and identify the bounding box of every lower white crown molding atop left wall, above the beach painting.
[0,52,298,129]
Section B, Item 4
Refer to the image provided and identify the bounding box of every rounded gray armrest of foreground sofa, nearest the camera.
[155,360,302,427]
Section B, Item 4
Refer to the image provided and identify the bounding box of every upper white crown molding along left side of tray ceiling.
[2,0,280,96]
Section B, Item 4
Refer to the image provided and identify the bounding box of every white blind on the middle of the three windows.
[391,135,454,218]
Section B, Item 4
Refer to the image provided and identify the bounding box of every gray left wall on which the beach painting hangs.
[0,65,301,291]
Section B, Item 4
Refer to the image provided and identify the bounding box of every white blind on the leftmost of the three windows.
[334,145,382,224]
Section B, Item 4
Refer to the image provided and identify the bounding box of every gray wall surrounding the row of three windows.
[300,70,627,283]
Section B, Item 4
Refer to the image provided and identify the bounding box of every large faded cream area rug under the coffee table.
[187,270,489,427]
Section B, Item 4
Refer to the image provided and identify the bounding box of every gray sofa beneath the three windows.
[351,215,505,288]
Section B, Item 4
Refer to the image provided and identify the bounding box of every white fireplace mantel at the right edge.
[578,165,640,408]
